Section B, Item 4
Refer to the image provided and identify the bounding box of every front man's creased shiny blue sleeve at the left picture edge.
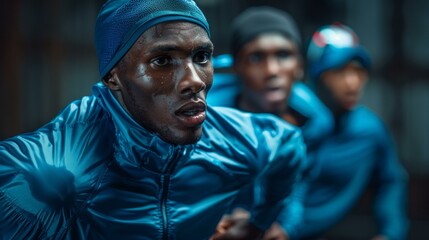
[0,98,113,239]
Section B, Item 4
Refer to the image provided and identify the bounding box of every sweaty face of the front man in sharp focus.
[105,22,213,145]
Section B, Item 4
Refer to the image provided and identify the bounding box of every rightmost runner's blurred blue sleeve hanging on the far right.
[374,126,409,240]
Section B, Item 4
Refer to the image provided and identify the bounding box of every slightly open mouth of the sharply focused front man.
[175,101,207,127]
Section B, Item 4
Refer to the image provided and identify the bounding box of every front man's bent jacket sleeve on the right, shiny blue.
[246,115,306,230]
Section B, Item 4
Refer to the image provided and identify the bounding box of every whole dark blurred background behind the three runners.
[0,0,429,240]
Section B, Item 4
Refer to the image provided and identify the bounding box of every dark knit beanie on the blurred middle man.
[230,6,301,57]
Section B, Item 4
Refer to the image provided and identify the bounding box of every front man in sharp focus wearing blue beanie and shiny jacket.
[0,0,305,239]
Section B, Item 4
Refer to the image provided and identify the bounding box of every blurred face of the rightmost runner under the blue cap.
[319,61,368,112]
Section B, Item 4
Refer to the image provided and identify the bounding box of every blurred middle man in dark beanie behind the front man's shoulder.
[207,6,333,239]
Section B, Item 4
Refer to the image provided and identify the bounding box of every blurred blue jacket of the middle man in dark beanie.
[207,71,334,235]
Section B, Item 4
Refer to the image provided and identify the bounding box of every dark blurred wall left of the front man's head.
[0,0,102,139]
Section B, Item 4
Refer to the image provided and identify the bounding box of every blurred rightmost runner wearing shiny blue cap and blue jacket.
[291,24,408,240]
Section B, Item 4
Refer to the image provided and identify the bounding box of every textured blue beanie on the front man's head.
[95,0,210,78]
